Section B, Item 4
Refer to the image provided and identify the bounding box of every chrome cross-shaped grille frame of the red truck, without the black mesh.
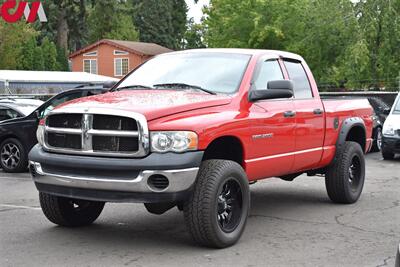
[44,107,150,157]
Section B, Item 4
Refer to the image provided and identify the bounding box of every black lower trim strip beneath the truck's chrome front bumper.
[35,183,191,203]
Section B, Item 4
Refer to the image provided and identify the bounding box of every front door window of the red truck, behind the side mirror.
[254,59,284,90]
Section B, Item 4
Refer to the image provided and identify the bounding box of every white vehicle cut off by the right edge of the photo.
[382,93,400,159]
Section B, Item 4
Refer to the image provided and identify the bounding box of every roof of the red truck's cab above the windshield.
[164,48,303,60]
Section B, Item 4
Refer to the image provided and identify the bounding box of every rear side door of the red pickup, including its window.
[284,59,325,172]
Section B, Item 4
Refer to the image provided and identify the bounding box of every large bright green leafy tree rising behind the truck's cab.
[204,0,364,90]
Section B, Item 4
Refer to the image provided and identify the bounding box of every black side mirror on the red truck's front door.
[249,80,293,102]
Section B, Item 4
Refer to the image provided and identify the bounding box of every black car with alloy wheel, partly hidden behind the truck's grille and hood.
[0,86,108,172]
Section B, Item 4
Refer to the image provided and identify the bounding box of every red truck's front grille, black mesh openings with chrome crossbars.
[45,113,148,157]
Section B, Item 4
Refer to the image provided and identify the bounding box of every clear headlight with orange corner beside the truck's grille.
[150,131,198,153]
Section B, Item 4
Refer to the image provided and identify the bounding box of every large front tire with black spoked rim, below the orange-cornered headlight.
[183,160,250,248]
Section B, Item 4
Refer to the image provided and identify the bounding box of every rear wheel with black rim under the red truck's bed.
[325,142,365,204]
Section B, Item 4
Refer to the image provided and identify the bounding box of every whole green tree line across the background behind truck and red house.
[0,0,400,90]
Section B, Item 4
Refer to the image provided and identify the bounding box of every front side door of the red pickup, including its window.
[246,59,296,179]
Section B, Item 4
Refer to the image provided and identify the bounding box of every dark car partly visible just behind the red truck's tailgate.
[368,97,390,152]
